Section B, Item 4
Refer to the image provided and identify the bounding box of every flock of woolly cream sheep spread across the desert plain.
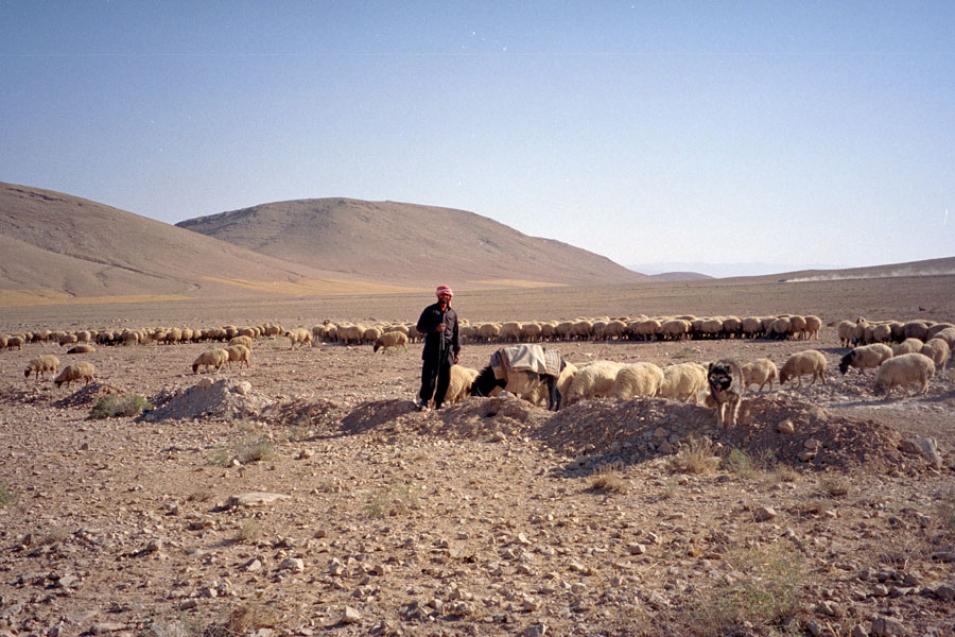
[0,314,955,405]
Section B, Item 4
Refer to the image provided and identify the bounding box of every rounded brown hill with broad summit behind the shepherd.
[177,199,646,288]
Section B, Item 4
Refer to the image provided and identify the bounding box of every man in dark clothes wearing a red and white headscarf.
[417,285,461,411]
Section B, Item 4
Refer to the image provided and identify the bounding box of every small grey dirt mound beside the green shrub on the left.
[143,378,272,422]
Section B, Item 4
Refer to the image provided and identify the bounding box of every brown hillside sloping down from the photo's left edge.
[0,183,414,306]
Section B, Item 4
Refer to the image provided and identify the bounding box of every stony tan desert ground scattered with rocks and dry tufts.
[0,277,955,637]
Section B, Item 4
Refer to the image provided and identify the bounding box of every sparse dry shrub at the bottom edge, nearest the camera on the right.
[687,544,806,637]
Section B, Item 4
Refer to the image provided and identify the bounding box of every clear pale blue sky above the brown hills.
[0,0,955,274]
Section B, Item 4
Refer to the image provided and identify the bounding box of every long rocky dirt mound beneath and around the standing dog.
[536,396,924,472]
